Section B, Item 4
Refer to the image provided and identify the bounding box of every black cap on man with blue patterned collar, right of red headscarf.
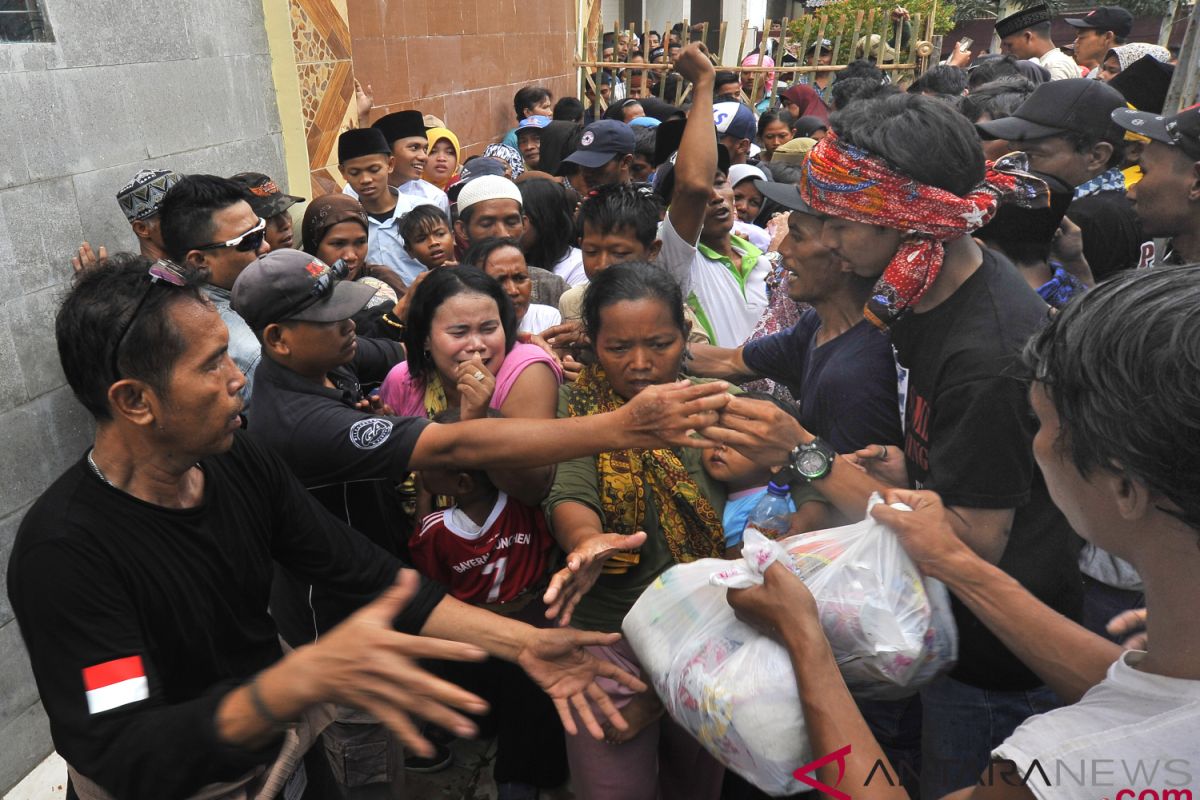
[976,78,1126,142]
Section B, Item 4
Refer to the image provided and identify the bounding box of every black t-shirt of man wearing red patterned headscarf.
[892,249,1082,690]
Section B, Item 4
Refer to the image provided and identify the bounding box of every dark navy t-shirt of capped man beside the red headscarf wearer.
[742,308,904,453]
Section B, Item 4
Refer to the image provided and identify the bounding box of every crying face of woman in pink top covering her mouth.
[425,291,506,386]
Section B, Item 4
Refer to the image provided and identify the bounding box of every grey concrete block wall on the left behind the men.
[0,0,286,794]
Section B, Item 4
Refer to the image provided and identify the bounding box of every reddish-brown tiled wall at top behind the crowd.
[347,0,576,160]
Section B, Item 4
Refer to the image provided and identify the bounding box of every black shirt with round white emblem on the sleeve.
[247,338,428,646]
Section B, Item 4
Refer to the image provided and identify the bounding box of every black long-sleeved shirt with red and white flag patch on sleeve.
[8,433,443,798]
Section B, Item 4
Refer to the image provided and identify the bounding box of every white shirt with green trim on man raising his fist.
[655,213,770,347]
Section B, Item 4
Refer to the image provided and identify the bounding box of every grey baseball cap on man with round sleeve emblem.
[230,249,376,331]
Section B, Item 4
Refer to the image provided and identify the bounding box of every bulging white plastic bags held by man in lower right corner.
[622,495,958,796]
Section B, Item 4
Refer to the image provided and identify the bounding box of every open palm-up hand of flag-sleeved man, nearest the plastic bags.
[517,627,647,740]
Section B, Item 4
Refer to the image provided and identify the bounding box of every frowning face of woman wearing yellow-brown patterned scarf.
[595,297,685,399]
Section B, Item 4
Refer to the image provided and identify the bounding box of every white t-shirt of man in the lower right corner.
[992,650,1200,800]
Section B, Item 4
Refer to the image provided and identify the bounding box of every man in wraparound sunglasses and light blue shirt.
[161,175,271,405]
